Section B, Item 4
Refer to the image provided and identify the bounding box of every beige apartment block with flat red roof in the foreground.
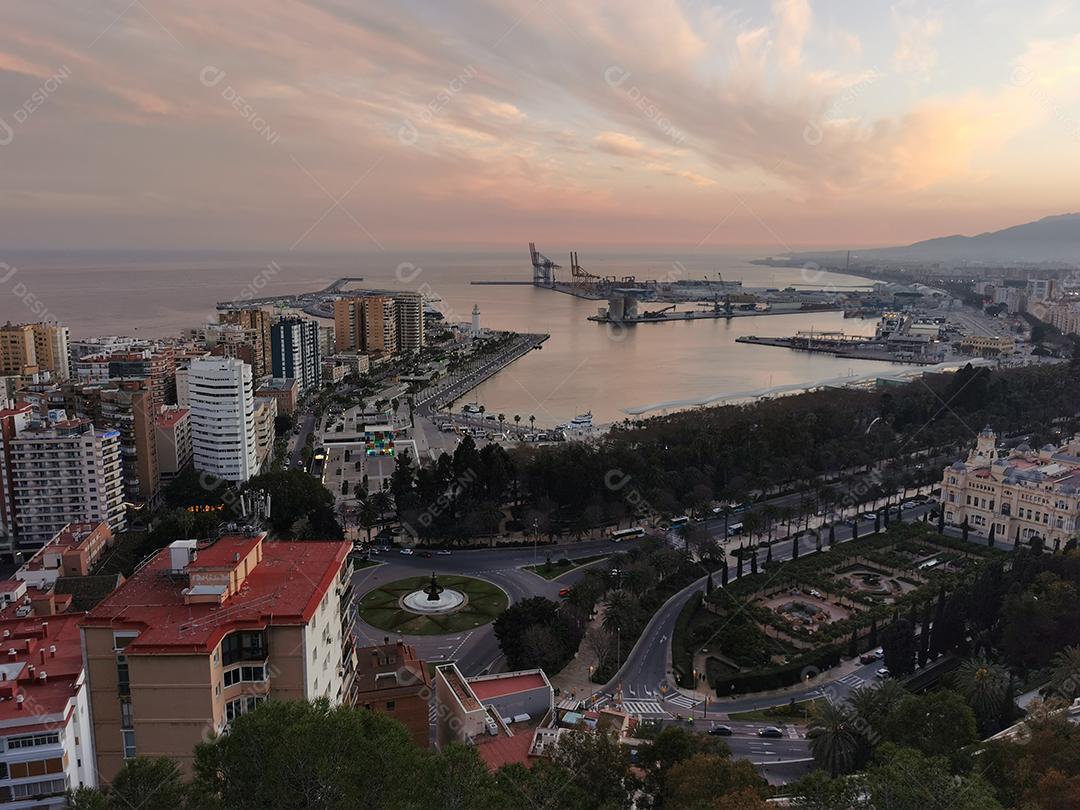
[82,535,355,781]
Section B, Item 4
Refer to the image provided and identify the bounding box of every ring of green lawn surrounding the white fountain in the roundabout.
[359,575,510,636]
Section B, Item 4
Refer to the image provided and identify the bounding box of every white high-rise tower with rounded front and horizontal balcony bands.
[187,357,258,481]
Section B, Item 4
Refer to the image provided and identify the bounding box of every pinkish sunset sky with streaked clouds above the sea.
[0,0,1080,253]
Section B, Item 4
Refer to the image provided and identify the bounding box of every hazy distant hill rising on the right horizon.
[859,214,1080,265]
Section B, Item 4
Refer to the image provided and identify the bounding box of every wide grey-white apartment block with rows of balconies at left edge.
[0,419,127,549]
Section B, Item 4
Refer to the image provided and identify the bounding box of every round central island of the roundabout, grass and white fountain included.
[357,573,510,635]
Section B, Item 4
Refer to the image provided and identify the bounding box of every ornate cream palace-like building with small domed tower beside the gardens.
[942,428,1080,545]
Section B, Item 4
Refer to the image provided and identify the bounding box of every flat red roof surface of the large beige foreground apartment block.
[83,537,351,654]
